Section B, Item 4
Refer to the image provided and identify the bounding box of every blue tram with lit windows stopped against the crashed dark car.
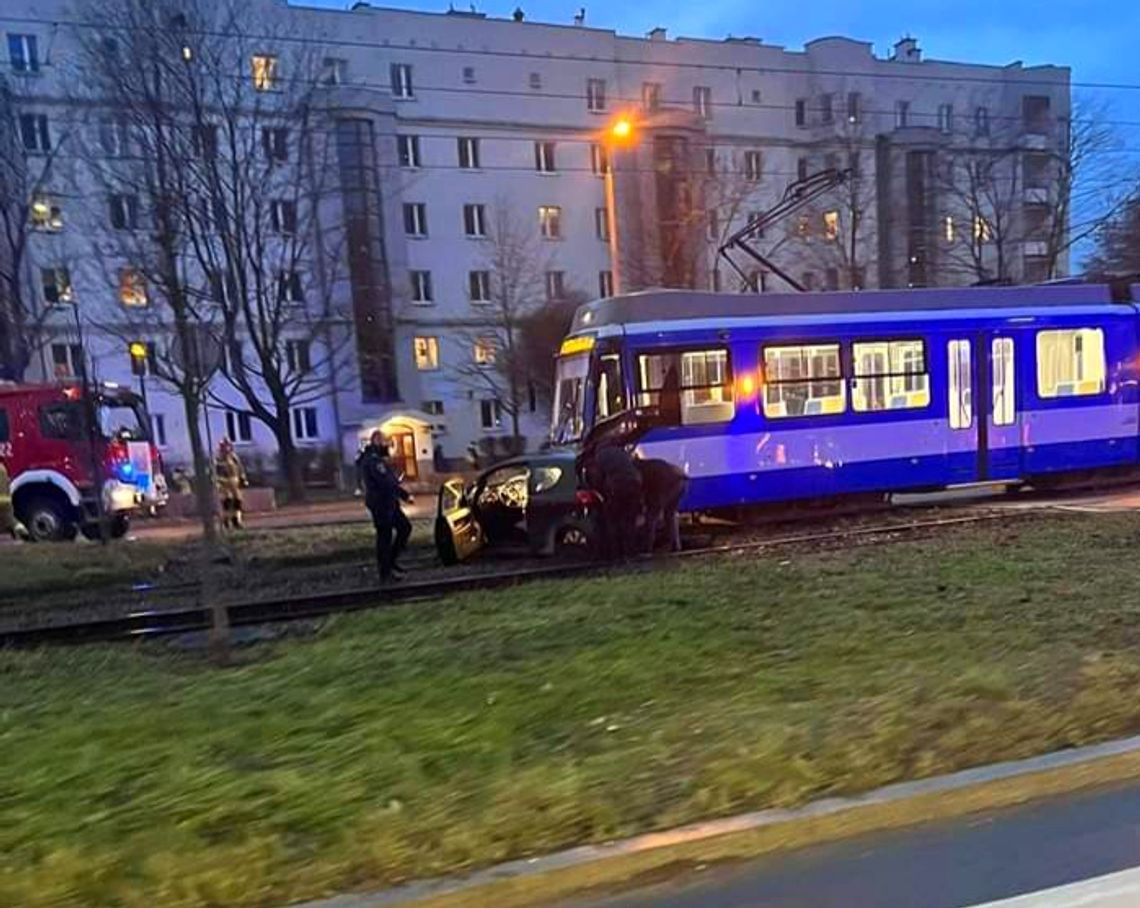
[552,284,1140,510]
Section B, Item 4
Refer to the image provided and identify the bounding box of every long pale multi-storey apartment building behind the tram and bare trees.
[0,0,1070,476]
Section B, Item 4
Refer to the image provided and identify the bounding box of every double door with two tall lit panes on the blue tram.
[946,332,1021,483]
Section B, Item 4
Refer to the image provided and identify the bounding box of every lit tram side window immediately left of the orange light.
[637,348,735,425]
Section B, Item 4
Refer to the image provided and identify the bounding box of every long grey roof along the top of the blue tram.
[571,283,1140,332]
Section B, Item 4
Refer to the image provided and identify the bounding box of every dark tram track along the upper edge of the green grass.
[0,510,1036,648]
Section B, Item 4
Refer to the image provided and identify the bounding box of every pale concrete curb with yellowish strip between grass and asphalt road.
[292,736,1140,908]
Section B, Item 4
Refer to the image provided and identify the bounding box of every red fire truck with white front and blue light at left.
[0,382,166,541]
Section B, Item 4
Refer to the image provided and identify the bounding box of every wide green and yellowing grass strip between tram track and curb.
[0,516,1140,908]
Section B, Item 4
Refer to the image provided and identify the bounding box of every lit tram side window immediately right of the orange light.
[764,343,847,419]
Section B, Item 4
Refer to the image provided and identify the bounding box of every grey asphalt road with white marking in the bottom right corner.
[577,784,1140,908]
